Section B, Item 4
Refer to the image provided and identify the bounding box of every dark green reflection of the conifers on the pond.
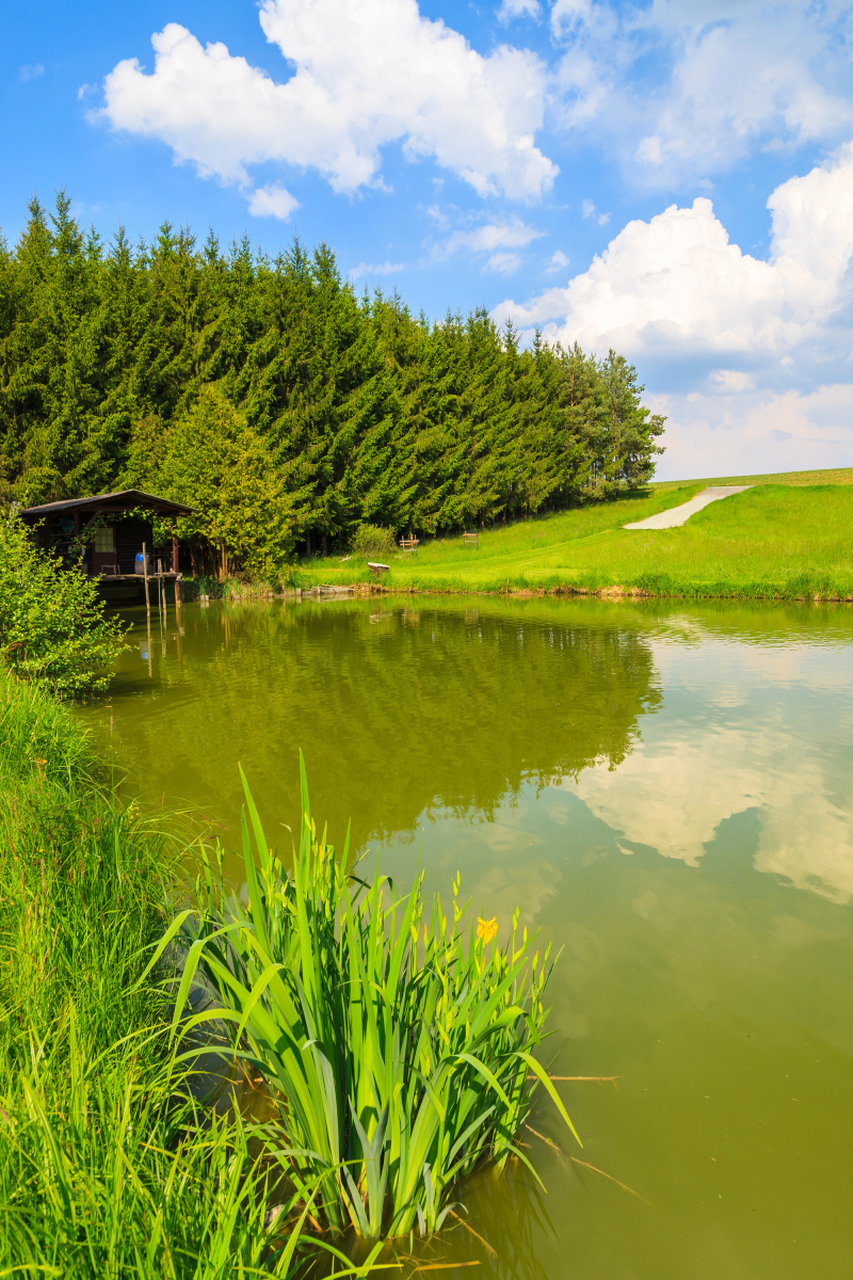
[104,602,661,844]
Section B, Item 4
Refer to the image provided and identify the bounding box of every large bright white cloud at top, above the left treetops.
[96,0,557,198]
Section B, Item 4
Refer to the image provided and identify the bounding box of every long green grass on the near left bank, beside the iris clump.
[0,675,371,1280]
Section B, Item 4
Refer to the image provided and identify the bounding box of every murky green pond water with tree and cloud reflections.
[85,598,853,1280]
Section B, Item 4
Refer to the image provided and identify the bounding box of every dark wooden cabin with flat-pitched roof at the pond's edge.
[20,489,193,598]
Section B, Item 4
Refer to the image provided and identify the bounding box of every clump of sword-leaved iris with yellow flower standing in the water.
[167,768,576,1238]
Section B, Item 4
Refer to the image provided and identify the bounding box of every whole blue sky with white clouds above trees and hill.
[0,0,853,477]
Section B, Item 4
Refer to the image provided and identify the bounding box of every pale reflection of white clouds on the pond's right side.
[564,645,853,901]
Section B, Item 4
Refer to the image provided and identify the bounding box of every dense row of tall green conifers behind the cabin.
[0,193,663,572]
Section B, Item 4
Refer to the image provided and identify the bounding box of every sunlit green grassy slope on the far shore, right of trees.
[296,477,853,599]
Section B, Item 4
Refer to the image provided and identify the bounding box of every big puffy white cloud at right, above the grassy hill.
[494,143,853,360]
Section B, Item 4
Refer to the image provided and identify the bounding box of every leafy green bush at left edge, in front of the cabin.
[0,511,124,698]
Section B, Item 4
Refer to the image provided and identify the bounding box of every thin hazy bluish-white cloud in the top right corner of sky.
[551,0,853,186]
